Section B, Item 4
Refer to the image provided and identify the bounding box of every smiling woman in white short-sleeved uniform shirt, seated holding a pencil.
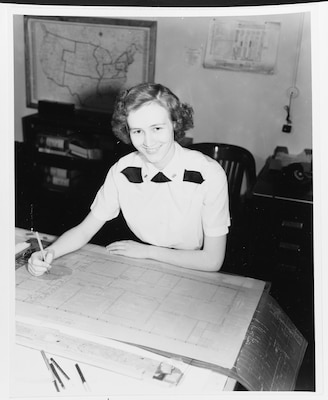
[29,83,230,275]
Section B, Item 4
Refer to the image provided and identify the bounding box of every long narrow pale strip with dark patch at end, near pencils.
[16,321,183,385]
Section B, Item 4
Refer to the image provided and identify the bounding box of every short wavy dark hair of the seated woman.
[112,83,194,144]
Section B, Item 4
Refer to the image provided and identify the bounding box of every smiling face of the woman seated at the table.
[127,103,174,169]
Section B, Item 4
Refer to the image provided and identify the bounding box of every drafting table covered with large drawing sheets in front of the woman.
[13,229,306,395]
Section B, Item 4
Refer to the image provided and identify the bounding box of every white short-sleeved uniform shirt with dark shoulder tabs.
[91,142,230,250]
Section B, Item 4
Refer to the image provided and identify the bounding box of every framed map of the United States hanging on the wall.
[24,16,157,112]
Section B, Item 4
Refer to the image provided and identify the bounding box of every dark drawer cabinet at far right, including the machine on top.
[247,158,314,348]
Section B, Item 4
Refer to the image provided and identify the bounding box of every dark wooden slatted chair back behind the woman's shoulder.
[189,143,256,219]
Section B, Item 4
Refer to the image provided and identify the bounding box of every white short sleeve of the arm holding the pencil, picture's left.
[90,164,120,221]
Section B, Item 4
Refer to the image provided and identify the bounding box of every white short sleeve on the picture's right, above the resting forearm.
[202,160,230,236]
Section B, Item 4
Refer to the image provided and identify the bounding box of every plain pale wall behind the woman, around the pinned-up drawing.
[14,13,312,171]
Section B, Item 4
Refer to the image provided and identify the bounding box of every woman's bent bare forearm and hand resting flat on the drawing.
[106,235,227,272]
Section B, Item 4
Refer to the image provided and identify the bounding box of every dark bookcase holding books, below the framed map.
[16,111,131,235]
